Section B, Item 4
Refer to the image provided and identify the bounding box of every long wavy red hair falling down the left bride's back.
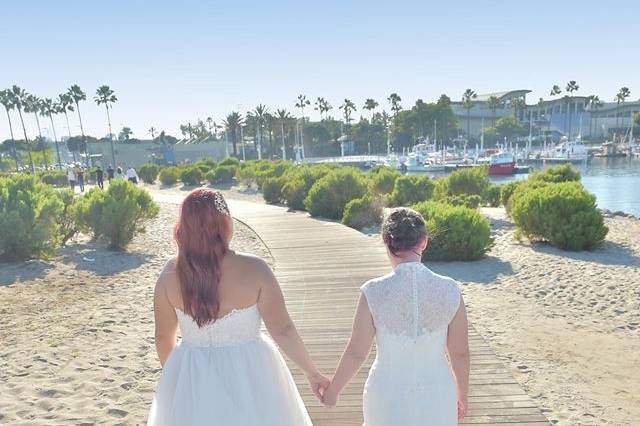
[173,188,231,327]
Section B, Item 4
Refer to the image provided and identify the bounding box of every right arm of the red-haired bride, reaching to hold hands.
[258,262,329,398]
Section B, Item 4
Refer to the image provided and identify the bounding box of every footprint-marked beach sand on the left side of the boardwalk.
[0,203,272,425]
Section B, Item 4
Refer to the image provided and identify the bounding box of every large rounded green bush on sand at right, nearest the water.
[511,181,608,250]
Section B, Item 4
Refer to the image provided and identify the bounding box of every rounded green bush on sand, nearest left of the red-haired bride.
[74,180,159,250]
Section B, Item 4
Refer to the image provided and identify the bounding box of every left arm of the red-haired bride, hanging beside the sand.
[153,268,178,367]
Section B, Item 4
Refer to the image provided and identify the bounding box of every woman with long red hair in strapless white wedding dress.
[148,188,329,426]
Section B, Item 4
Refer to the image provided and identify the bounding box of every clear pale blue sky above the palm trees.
[0,0,640,140]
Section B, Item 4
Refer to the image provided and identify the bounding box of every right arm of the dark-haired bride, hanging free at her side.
[447,296,471,418]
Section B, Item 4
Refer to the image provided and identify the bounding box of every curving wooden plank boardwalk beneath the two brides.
[230,201,549,426]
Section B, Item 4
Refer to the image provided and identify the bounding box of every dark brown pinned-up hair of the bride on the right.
[382,207,428,256]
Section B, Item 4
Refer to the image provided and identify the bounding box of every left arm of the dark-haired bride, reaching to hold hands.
[322,293,376,406]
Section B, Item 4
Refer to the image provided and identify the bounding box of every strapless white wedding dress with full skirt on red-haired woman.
[147,305,311,426]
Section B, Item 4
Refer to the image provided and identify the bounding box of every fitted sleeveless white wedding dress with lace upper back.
[362,262,460,426]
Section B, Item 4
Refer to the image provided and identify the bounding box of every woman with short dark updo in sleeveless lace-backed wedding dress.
[323,208,469,426]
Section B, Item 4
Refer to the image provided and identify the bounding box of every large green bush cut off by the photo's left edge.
[0,175,64,260]
